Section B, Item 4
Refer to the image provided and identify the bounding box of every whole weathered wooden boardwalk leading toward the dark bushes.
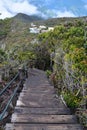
[6,69,82,130]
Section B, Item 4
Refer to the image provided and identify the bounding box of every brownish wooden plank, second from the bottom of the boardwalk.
[11,113,77,124]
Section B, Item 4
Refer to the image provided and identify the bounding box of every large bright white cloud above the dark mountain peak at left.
[0,0,38,19]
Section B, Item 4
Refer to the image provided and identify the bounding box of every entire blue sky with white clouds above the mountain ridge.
[0,0,87,19]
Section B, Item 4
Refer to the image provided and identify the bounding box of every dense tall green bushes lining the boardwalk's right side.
[38,21,87,125]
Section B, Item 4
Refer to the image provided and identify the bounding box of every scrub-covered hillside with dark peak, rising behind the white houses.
[0,13,86,47]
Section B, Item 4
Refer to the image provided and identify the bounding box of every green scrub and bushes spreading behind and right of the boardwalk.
[0,14,87,125]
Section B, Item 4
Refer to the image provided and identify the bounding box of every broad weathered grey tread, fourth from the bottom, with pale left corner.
[16,93,65,107]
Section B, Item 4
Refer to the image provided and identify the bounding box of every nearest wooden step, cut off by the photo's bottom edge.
[5,124,82,130]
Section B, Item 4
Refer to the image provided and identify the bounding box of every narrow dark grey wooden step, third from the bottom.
[14,107,70,115]
